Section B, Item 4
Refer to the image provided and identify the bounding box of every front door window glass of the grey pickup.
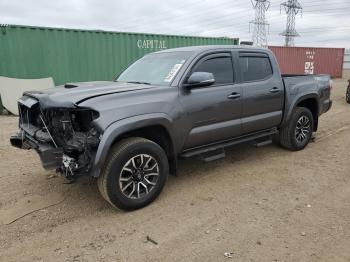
[193,57,233,85]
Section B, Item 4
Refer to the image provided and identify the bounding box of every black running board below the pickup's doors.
[180,128,277,158]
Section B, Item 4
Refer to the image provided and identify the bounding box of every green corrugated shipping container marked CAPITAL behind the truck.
[0,25,238,85]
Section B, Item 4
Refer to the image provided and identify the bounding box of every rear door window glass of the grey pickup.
[239,56,273,82]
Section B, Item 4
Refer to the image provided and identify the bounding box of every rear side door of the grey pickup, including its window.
[238,52,284,134]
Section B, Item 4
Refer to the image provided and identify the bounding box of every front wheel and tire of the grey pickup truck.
[97,137,169,210]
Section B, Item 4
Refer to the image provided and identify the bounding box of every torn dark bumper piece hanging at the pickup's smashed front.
[10,130,63,170]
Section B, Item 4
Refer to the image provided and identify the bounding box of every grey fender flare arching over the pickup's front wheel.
[91,113,174,177]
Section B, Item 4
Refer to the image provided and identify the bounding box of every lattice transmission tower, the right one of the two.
[281,0,303,46]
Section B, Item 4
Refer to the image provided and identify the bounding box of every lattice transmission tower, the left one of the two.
[250,0,270,47]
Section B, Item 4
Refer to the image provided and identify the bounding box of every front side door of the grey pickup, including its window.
[180,52,242,149]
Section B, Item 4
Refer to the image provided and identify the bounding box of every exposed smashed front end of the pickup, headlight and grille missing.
[11,98,100,178]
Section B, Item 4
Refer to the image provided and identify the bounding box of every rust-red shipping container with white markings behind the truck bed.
[269,46,344,78]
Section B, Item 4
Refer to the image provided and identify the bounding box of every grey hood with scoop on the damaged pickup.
[23,81,152,109]
